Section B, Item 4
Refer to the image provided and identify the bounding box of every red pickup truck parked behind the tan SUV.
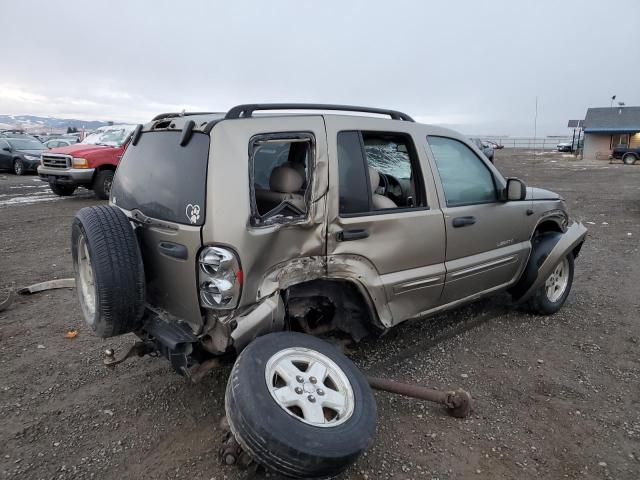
[38,125,136,200]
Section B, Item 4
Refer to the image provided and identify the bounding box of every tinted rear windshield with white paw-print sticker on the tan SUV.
[111,132,209,225]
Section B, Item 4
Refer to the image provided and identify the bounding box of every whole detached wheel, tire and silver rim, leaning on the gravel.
[225,332,376,478]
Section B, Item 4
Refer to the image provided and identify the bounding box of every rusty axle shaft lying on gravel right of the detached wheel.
[367,377,472,418]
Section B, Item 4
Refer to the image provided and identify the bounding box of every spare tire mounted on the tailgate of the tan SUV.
[71,205,145,338]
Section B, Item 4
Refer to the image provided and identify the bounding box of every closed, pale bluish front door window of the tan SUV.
[427,136,498,207]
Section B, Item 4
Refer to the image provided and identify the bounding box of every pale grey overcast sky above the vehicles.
[0,0,640,136]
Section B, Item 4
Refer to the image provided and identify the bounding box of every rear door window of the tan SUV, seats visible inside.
[337,131,425,215]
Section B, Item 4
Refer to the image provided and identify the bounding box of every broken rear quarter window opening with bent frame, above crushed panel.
[249,133,315,225]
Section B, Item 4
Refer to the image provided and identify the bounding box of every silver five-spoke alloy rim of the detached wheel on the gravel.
[265,347,354,427]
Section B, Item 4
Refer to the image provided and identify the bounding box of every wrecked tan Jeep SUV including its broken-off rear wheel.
[72,104,586,477]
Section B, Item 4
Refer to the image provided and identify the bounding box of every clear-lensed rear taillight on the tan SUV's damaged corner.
[198,247,243,310]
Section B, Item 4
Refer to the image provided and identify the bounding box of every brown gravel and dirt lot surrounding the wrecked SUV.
[0,151,640,480]
